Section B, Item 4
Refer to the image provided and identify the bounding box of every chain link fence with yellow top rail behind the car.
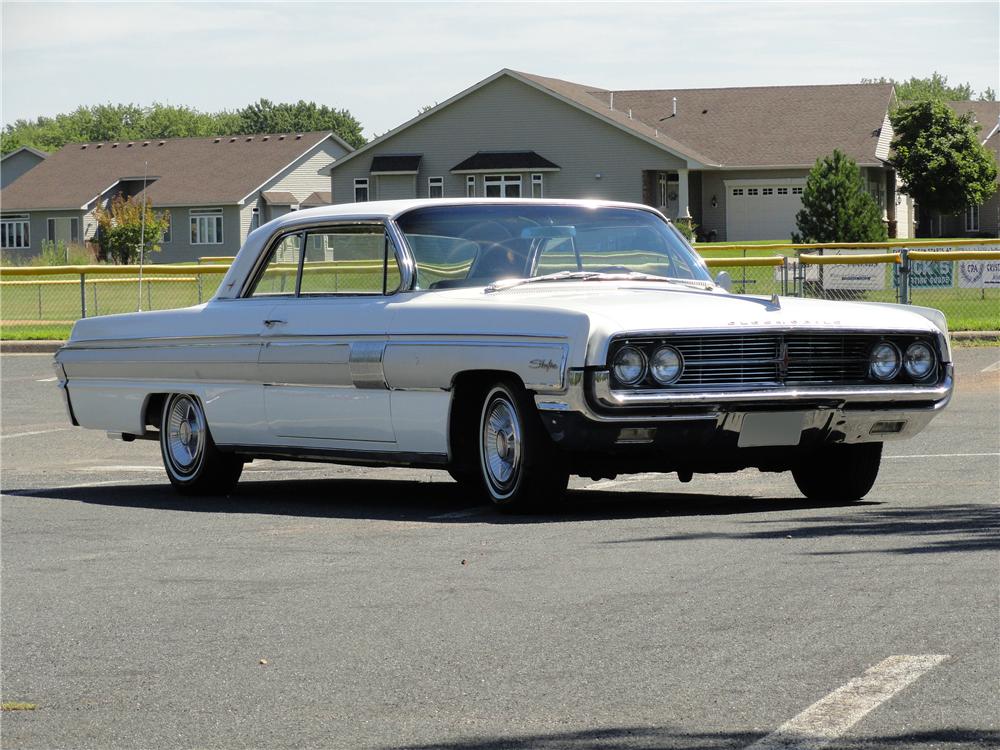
[0,240,1000,337]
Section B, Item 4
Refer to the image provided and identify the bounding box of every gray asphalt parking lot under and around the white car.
[0,348,1000,750]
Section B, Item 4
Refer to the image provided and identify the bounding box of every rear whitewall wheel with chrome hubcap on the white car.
[160,393,243,495]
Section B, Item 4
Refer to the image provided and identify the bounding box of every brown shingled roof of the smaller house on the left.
[0,131,351,210]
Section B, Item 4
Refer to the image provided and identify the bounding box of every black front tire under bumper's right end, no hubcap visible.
[792,443,882,503]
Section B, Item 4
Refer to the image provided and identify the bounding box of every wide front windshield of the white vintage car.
[397,203,711,290]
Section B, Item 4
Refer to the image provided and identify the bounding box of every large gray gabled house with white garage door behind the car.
[331,69,912,240]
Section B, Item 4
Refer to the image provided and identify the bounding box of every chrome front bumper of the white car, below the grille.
[535,364,954,443]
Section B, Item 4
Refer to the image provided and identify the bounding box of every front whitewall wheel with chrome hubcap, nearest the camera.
[479,381,569,511]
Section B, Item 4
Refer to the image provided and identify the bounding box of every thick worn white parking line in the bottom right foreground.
[747,654,948,750]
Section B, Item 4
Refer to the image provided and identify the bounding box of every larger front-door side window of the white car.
[299,224,402,295]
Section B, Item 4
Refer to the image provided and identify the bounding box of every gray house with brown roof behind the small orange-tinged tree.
[0,132,351,263]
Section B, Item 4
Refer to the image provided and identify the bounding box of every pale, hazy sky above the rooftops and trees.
[0,0,1000,137]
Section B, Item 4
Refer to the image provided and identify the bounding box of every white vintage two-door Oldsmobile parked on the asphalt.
[56,199,953,508]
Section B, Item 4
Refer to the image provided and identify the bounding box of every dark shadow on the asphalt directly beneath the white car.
[6,478,877,524]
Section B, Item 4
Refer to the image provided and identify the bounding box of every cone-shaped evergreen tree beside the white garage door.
[792,150,888,242]
